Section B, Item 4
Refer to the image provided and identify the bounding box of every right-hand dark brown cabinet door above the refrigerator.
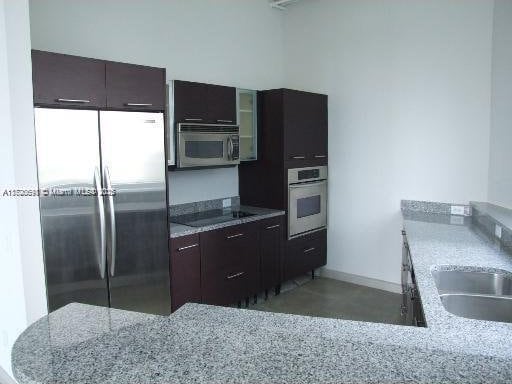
[105,61,165,111]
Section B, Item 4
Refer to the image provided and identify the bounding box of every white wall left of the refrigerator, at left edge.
[0,0,46,374]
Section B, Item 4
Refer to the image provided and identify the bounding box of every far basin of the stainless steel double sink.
[432,271,512,296]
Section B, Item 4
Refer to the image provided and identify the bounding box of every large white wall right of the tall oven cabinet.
[284,0,493,283]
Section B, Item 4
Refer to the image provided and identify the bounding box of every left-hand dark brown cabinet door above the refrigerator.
[32,50,106,108]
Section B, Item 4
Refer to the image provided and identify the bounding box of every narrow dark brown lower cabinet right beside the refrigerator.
[170,234,201,312]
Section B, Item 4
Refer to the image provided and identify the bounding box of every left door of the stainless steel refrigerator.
[35,108,109,311]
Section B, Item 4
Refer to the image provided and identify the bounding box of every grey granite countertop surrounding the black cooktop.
[169,205,285,239]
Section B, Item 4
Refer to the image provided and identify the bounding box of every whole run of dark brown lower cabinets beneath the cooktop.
[170,216,284,311]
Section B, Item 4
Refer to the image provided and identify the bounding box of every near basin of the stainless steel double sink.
[440,294,512,323]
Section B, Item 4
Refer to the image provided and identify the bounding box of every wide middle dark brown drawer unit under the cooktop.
[200,222,259,305]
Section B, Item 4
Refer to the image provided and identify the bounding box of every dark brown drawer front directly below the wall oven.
[283,230,327,280]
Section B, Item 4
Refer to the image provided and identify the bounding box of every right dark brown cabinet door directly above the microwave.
[207,85,236,124]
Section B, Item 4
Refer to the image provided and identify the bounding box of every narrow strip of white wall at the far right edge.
[489,0,512,208]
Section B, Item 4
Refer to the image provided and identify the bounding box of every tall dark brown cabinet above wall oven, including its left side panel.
[238,89,328,210]
